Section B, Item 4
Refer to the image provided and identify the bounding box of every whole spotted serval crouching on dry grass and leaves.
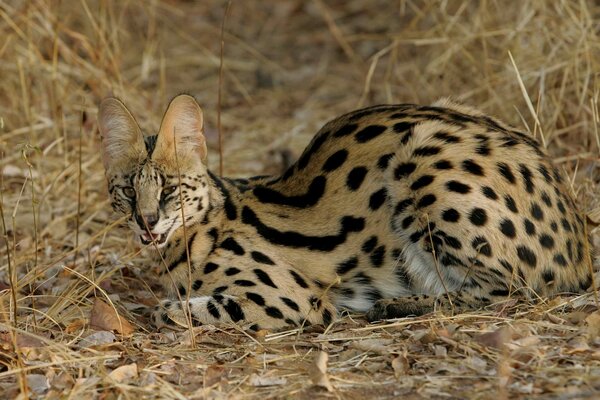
[99,95,591,329]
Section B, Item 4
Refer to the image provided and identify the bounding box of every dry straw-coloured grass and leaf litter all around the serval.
[0,0,600,398]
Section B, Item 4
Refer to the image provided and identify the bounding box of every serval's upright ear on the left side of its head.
[98,97,147,170]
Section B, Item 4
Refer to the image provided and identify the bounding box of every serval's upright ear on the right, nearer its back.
[152,94,206,163]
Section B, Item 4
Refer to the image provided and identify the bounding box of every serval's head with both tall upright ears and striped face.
[98,95,210,247]
